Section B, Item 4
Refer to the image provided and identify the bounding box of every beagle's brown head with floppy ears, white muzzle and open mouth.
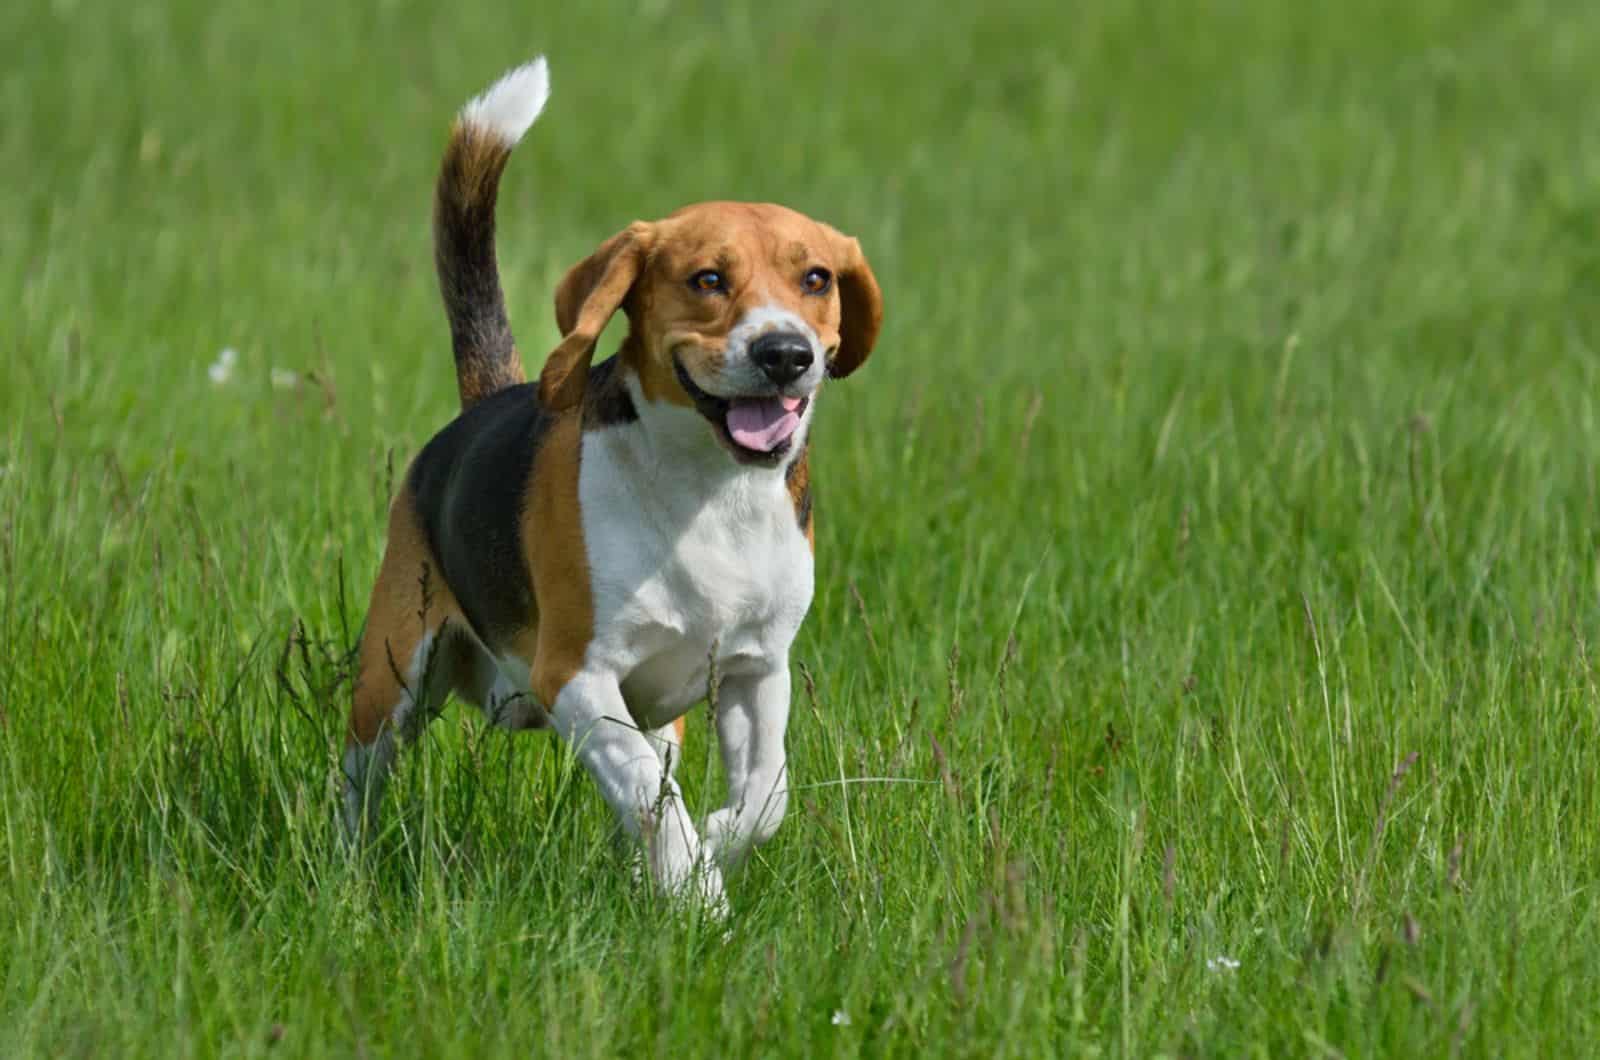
[539,202,883,464]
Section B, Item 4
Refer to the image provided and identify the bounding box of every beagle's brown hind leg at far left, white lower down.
[342,490,466,844]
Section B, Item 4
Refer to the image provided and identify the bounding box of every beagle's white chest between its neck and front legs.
[579,436,813,725]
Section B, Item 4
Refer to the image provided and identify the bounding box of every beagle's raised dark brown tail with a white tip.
[434,56,550,408]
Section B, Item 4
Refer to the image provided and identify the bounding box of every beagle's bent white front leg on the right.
[706,660,789,871]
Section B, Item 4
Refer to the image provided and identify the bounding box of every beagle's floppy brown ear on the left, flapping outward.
[539,221,653,410]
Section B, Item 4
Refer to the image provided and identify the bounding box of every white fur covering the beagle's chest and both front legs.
[552,373,814,909]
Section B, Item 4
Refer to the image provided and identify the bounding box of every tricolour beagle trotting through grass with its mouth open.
[344,58,883,909]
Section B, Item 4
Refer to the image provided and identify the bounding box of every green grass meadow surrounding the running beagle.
[0,0,1600,1057]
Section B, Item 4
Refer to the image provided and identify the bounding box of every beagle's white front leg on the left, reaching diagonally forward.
[550,673,725,911]
